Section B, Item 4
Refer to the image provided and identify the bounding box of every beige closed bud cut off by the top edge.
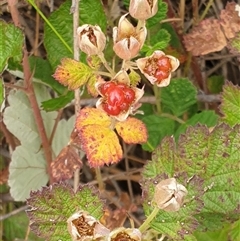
[129,0,158,20]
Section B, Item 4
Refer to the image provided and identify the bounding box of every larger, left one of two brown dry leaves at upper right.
[184,19,227,56]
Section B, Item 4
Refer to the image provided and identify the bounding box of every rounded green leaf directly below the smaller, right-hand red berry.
[161,79,197,116]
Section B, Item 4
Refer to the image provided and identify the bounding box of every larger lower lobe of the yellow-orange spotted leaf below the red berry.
[79,124,122,167]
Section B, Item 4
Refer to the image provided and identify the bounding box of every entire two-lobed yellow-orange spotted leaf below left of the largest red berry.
[76,108,122,167]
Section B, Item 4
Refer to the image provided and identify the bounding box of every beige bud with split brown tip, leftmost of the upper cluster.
[77,24,106,55]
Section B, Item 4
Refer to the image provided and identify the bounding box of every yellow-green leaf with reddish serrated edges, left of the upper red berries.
[53,58,93,90]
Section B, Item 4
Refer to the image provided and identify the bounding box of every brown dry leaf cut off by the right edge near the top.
[219,2,240,39]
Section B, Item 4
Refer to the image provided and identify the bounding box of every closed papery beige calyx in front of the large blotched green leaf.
[153,178,188,212]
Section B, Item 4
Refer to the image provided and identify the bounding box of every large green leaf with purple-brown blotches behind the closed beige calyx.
[142,124,240,240]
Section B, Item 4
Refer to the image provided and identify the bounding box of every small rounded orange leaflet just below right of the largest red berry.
[116,117,148,144]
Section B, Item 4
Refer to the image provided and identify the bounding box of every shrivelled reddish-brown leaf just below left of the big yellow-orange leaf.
[51,146,82,182]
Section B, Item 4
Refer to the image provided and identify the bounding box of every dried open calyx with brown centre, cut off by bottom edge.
[107,227,142,241]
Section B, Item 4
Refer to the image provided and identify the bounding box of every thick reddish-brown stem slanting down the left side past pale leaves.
[8,0,53,184]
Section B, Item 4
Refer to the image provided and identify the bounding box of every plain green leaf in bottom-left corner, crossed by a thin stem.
[3,212,42,241]
